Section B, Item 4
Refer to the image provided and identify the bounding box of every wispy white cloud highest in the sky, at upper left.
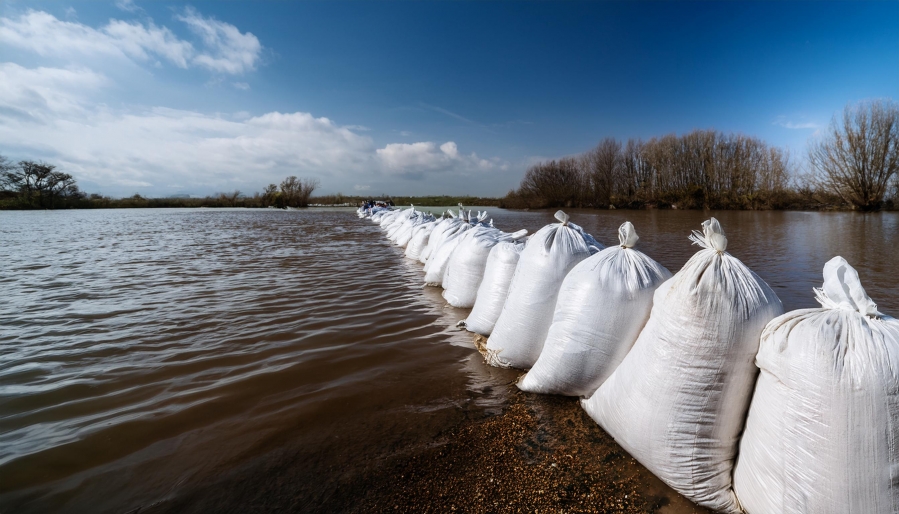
[0,9,262,75]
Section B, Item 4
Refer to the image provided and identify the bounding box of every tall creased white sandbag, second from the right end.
[582,218,783,513]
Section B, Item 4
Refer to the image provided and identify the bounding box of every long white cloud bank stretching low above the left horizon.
[0,63,506,194]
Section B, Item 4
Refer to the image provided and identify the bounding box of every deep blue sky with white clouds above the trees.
[0,0,899,196]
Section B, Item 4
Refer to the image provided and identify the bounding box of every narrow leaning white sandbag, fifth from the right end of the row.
[459,242,524,336]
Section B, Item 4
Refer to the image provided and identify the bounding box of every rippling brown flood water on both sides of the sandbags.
[0,208,899,512]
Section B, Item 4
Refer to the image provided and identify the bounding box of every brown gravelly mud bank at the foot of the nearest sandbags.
[142,370,708,513]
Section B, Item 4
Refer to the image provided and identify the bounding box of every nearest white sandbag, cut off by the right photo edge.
[734,257,899,514]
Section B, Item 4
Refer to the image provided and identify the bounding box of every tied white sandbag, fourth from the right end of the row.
[486,211,598,369]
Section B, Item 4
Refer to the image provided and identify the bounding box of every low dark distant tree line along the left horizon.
[0,160,319,209]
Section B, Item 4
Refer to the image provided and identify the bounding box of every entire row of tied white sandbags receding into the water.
[359,205,899,514]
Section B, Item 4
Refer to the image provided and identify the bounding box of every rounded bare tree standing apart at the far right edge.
[809,100,899,211]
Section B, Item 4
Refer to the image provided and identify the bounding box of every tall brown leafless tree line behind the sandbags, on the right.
[503,100,899,211]
